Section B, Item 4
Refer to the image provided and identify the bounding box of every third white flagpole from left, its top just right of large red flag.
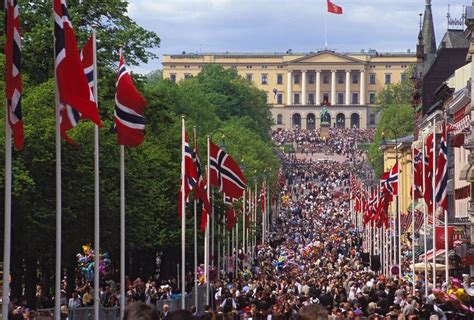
[92,25,100,320]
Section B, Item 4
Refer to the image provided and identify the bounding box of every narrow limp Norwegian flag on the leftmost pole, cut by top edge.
[5,0,25,150]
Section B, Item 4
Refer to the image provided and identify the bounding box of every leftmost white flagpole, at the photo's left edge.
[2,101,12,319]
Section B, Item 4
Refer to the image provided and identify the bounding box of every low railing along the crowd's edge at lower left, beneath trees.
[32,286,206,320]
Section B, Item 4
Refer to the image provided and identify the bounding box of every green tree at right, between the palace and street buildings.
[368,67,414,177]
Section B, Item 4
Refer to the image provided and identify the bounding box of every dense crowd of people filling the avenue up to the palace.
[6,129,474,320]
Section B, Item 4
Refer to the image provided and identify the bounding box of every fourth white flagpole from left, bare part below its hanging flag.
[120,145,125,319]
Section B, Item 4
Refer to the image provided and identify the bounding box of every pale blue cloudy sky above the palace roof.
[128,0,471,73]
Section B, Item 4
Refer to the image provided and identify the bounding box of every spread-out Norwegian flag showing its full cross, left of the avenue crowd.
[209,142,247,199]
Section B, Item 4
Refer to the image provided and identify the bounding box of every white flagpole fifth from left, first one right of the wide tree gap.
[181,116,186,309]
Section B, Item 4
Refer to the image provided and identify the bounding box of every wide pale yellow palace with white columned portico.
[163,50,416,129]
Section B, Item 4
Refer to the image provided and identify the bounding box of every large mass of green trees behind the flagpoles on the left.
[0,0,279,305]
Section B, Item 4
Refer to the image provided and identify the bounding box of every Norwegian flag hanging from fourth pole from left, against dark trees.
[115,52,146,147]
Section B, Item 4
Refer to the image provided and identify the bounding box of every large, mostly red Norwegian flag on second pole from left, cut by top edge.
[54,0,102,127]
